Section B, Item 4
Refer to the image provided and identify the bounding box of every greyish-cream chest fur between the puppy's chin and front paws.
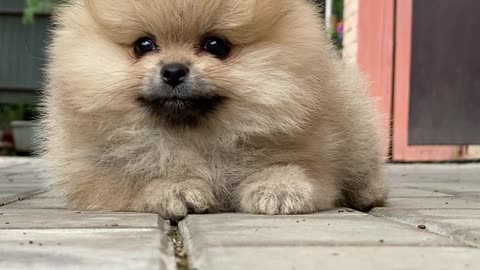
[99,131,261,191]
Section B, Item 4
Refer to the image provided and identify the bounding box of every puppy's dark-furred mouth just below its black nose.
[138,95,225,126]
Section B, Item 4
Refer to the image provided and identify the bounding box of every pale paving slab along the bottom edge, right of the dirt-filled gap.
[191,246,480,270]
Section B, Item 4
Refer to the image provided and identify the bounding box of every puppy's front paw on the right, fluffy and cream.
[236,167,316,215]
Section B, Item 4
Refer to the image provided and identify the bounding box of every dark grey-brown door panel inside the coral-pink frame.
[408,0,480,145]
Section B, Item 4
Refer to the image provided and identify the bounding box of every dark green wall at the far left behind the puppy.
[0,0,49,103]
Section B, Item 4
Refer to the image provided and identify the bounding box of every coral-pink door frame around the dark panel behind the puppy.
[358,0,465,162]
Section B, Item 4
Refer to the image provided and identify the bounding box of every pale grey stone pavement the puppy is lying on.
[0,158,480,270]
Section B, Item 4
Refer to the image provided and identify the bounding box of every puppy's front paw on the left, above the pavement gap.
[131,180,216,220]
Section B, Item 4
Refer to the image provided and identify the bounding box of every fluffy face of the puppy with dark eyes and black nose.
[50,0,334,133]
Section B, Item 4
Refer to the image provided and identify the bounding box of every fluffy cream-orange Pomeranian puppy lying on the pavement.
[43,0,386,219]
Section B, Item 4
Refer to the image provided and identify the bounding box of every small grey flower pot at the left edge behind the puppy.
[11,121,38,153]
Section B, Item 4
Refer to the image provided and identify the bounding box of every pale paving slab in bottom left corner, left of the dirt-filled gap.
[0,229,175,270]
